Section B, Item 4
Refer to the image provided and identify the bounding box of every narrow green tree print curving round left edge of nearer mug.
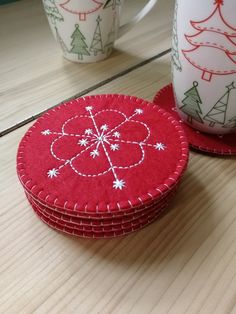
[171,0,182,72]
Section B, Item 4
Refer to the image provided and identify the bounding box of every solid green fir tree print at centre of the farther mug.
[70,24,90,60]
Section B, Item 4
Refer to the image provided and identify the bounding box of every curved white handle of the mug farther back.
[116,0,157,39]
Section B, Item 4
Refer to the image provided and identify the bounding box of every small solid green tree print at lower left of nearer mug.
[180,82,203,124]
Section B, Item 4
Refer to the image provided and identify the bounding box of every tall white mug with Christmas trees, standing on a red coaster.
[172,0,236,134]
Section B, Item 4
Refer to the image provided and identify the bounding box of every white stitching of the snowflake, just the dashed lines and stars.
[41,106,166,190]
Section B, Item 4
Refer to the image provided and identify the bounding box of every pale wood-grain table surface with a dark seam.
[0,0,236,314]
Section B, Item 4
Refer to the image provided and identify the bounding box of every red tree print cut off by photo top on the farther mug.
[60,0,103,21]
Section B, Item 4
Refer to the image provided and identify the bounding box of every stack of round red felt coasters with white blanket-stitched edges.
[17,95,189,238]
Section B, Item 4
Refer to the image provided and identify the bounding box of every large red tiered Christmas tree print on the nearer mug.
[182,0,236,81]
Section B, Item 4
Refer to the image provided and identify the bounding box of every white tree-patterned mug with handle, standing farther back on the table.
[43,0,157,63]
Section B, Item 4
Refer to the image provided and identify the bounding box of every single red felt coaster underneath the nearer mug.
[153,84,236,155]
